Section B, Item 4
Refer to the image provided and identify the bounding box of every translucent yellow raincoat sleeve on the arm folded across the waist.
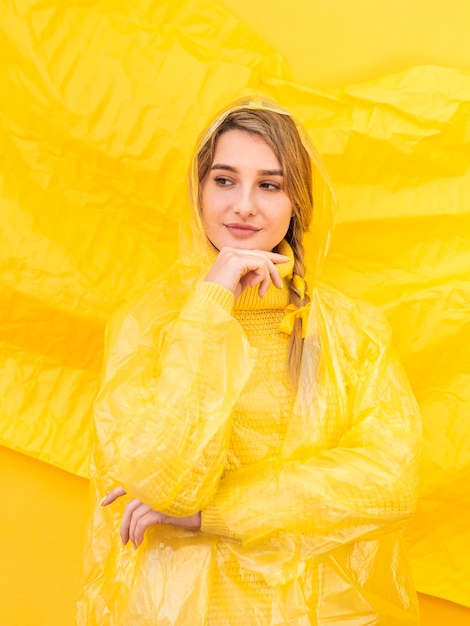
[202,298,420,558]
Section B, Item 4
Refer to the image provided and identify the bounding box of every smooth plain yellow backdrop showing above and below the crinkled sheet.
[0,0,470,626]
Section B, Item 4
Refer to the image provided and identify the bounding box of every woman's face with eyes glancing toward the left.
[202,129,292,252]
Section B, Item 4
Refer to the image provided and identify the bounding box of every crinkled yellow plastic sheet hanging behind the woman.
[0,1,470,605]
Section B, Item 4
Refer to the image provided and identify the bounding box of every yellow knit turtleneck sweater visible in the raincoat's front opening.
[198,242,294,626]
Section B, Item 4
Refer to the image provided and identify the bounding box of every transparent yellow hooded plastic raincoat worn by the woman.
[78,98,420,626]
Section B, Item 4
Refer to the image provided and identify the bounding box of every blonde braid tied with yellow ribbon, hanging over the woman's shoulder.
[287,218,310,388]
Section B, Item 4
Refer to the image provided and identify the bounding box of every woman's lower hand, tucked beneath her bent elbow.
[101,487,201,548]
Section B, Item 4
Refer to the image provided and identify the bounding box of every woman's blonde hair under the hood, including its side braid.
[197,108,313,387]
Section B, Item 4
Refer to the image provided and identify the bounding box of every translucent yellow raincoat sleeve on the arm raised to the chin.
[95,282,252,516]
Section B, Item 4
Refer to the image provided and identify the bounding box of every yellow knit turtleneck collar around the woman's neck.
[234,240,294,311]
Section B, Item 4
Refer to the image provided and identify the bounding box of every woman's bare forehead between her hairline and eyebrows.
[212,129,280,169]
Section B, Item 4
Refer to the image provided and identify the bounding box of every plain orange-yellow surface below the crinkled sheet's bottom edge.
[0,447,470,626]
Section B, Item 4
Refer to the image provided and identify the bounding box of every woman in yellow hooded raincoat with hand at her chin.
[79,100,419,626]
